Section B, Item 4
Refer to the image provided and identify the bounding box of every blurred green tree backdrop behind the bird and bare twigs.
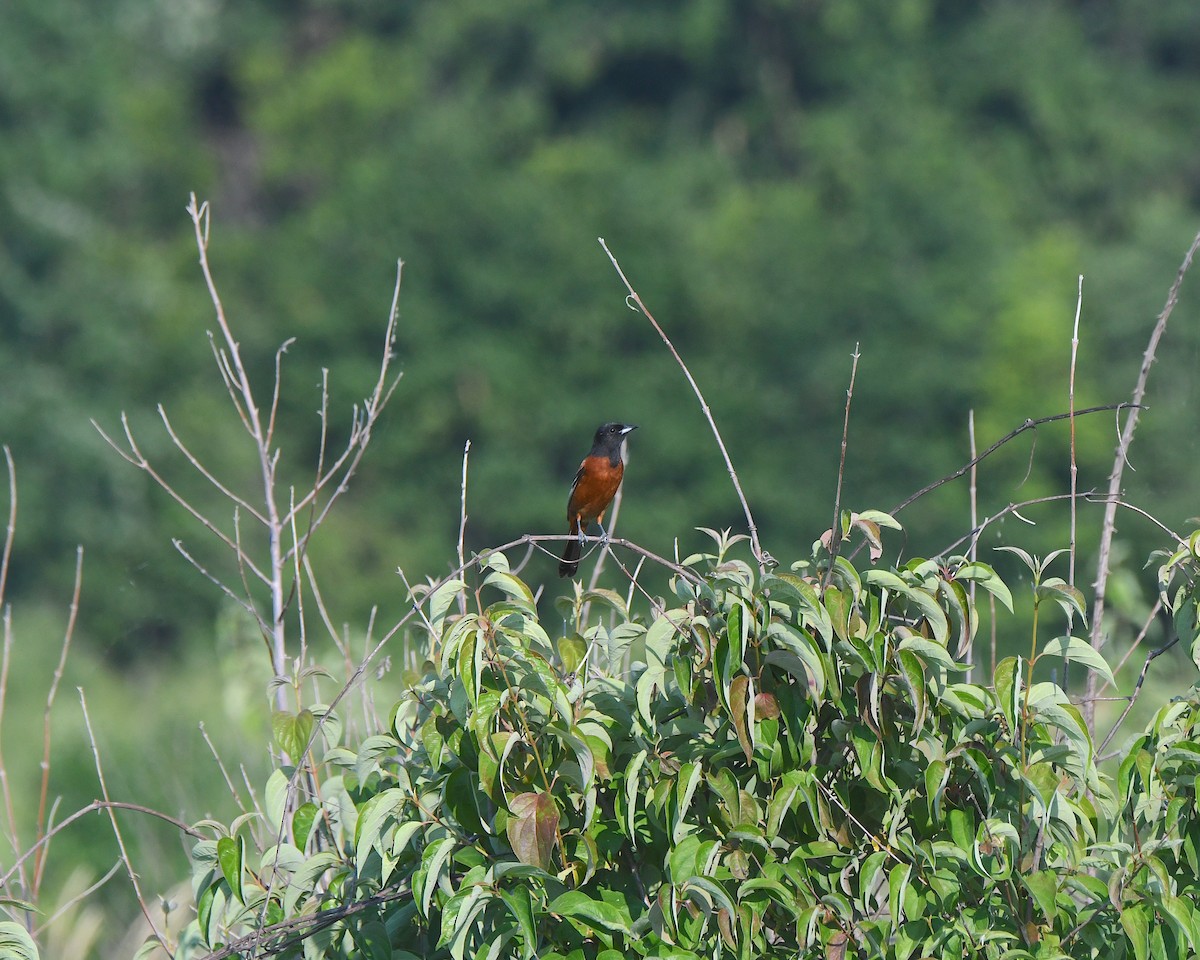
[0,0,1200,955]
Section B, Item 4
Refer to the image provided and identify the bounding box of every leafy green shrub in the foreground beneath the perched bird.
[171,525,1200,960]
